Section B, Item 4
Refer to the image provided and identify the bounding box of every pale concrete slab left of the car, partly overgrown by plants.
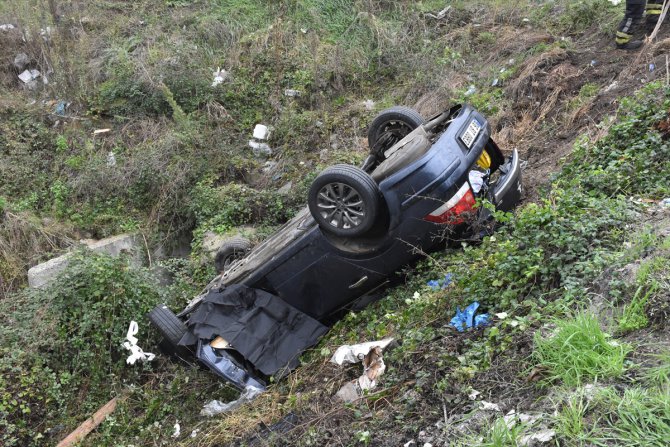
[28,234,142,288]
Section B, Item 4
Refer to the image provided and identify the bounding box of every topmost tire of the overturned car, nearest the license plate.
[368,106,426,154]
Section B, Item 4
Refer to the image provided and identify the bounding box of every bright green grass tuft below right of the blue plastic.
[533,313,631,386]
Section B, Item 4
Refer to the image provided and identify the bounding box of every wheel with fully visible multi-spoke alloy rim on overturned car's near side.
[307,164,380,237]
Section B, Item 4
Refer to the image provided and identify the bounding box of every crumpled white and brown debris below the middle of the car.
[330,338,393,402]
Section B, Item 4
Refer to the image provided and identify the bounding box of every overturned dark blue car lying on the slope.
[149,105,521,389]
